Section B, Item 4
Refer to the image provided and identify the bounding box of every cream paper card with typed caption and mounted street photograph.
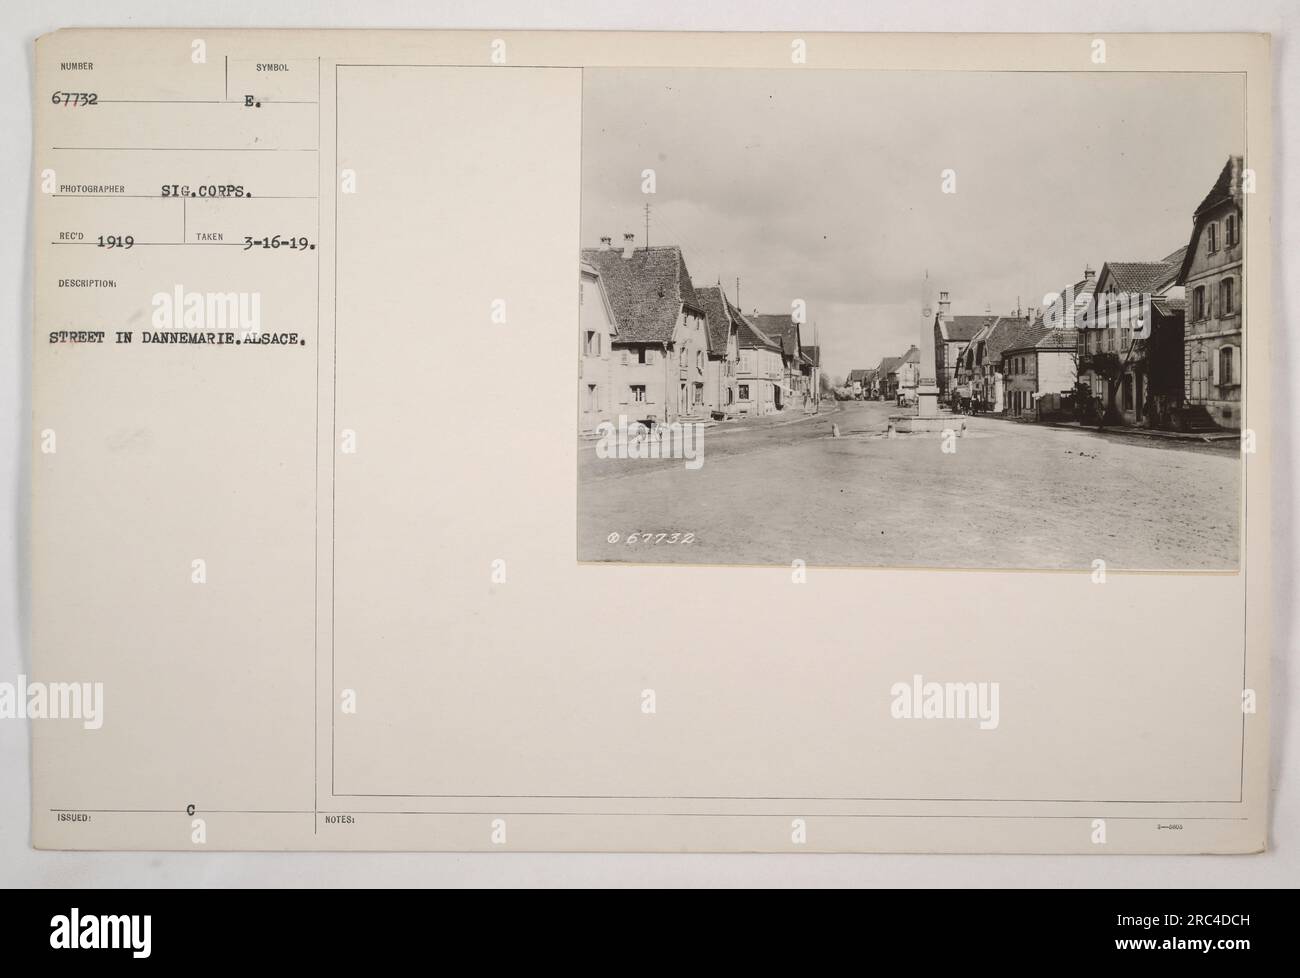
[30,30,1273,853]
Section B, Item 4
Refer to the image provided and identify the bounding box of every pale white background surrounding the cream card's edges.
[0,0,1300,887]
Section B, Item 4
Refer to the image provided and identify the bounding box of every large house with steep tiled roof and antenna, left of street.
[582,234,711,423]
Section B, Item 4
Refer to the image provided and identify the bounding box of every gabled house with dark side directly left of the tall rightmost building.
[1075,248,1186,427]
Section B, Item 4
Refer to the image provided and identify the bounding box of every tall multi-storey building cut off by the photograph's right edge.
[1177,156,1245,429]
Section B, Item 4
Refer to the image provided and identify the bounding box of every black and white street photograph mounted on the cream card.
[577,69,1255,571]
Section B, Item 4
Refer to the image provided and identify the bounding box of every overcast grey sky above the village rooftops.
[582,68,1244,376]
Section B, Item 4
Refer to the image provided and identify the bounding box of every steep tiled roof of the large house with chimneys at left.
[582,245,703,343]
